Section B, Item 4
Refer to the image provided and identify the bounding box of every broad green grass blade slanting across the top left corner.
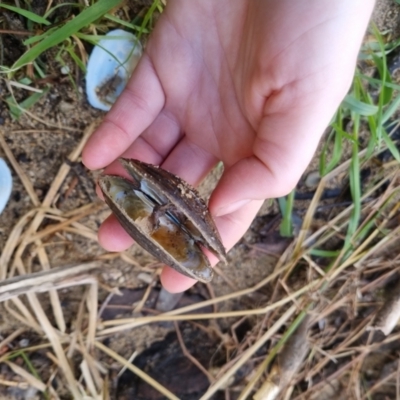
[13,0,122,68]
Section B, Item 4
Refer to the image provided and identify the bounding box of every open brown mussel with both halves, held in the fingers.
[99,158,226,282]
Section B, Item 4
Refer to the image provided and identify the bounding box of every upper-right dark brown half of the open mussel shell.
[119,158,226,262]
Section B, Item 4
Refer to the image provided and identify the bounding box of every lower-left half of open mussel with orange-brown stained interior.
[99,176,213,282]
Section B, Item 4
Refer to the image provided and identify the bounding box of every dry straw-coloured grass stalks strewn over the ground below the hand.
[0,109,400,400]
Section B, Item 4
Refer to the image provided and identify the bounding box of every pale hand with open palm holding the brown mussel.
[83,0,374,292]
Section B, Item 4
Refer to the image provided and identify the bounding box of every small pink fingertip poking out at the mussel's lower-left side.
[97,215,133,252]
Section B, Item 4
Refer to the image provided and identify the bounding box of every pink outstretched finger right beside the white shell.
[82,54,165,169]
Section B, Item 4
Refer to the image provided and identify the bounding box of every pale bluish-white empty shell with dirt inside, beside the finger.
[86,29,142,111]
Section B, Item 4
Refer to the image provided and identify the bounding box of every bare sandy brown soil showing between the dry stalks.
[0,0,400,400]
